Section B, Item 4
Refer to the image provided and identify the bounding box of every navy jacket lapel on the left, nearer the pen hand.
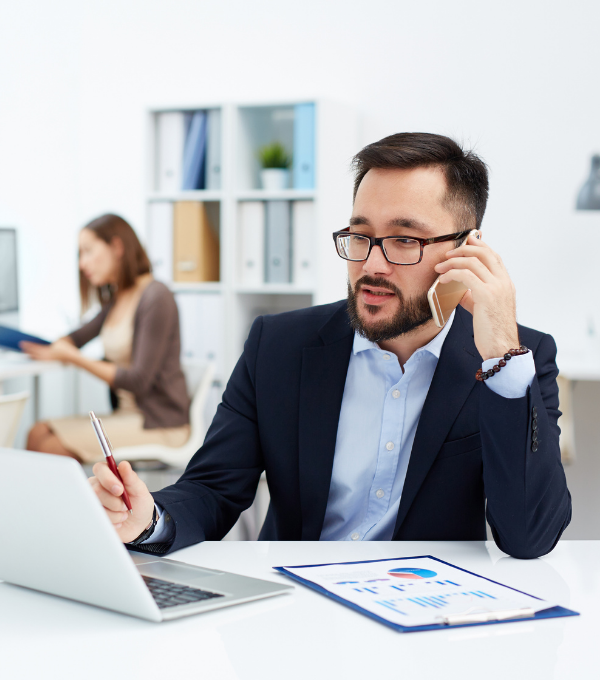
[299,305,354,541]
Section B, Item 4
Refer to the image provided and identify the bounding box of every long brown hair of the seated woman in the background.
[79,214,152,313]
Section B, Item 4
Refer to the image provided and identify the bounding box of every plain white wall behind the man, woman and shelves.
[0,0,600,347]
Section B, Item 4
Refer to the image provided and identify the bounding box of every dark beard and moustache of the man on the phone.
[348,276,432,342]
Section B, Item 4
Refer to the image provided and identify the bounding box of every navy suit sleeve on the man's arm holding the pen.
[153,317,264,552]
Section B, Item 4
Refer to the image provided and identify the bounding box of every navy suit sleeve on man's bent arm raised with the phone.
[480,335,571,559]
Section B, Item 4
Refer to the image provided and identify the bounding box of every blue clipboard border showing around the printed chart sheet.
[273,555,579,633]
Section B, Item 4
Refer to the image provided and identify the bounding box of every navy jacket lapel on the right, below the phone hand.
[394,307,481,536]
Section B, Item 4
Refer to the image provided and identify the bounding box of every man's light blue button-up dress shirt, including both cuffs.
[144,312,535,543]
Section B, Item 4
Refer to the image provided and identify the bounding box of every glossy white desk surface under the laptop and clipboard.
[0,541,600,680]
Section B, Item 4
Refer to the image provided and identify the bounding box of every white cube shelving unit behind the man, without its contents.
[146,100,358,384]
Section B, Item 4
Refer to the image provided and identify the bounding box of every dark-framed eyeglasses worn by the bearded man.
[333,227,471,264]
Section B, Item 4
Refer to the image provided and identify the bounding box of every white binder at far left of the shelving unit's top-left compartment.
[155,111,185,193]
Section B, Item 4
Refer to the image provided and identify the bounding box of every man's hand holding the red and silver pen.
[89,461,154,543]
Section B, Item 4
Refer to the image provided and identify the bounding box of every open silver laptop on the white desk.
[0,449,293,621]
